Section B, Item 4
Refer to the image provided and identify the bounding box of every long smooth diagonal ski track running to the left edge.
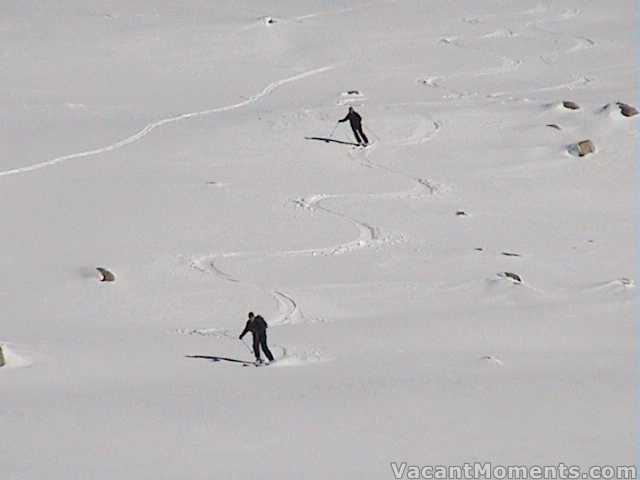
[0,65,336,177]
